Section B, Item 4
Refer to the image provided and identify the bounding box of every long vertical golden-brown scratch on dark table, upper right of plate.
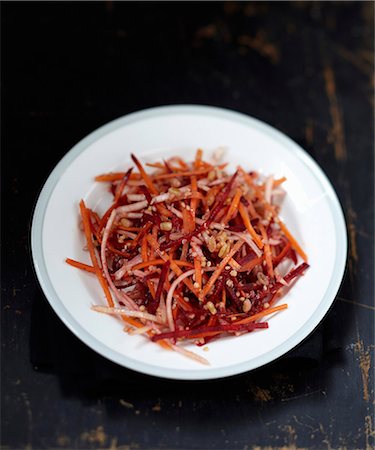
[323,64,346,161]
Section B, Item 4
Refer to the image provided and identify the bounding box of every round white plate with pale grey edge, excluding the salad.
[32,106,347,380]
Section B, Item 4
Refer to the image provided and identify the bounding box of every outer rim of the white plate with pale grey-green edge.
[31,104,348,381]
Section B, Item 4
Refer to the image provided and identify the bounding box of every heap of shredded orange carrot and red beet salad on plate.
[66,150,309,364]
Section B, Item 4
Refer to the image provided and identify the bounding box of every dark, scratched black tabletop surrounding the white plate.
[1,2,374,450]
